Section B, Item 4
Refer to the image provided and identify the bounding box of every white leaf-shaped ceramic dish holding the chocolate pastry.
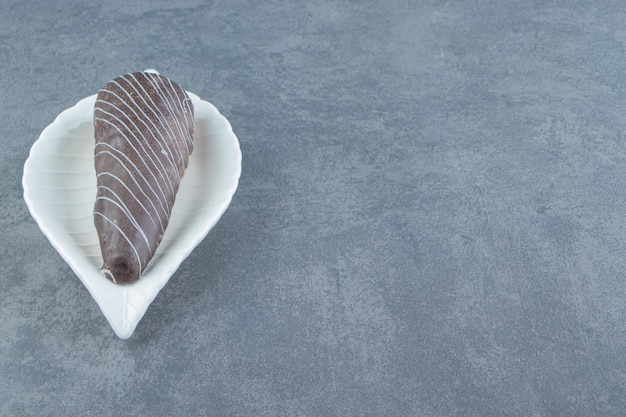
[22,93,241,339]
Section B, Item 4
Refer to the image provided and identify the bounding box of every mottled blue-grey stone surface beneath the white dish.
[0,0,626,417]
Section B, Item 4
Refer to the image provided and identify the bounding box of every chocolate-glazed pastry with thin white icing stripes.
[94,72,194,283]
